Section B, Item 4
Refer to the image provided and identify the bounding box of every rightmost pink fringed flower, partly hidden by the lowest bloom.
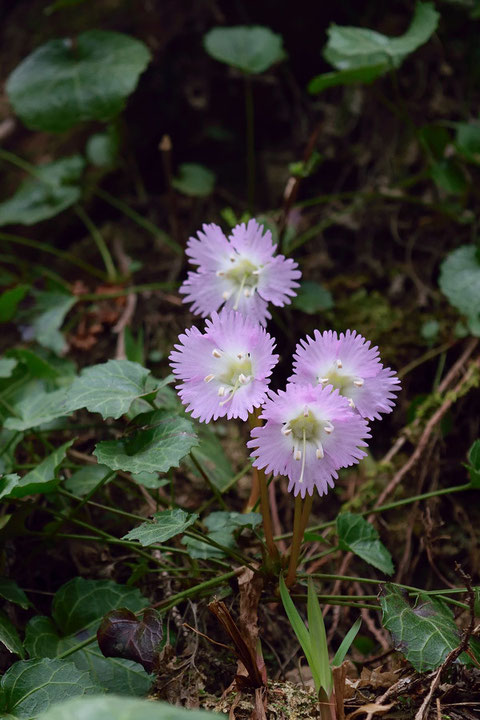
[289,330,400,420]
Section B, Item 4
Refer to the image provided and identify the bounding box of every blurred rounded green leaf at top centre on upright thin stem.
[203,26,285,74]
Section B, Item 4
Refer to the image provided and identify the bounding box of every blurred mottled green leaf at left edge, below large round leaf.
[0,155,85,226]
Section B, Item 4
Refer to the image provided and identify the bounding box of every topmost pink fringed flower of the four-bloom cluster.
[180,220,301,325]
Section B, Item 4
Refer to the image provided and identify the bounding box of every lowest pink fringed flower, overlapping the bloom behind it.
[247,384,370,498]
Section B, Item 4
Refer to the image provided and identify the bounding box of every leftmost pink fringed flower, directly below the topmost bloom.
[170,310,278,422]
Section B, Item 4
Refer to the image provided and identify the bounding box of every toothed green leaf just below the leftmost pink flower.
[94,410,198,473]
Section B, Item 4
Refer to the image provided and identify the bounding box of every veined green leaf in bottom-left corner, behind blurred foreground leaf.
[0,659,99,718]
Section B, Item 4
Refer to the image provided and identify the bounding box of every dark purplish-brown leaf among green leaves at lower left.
[97,608,163,673]
